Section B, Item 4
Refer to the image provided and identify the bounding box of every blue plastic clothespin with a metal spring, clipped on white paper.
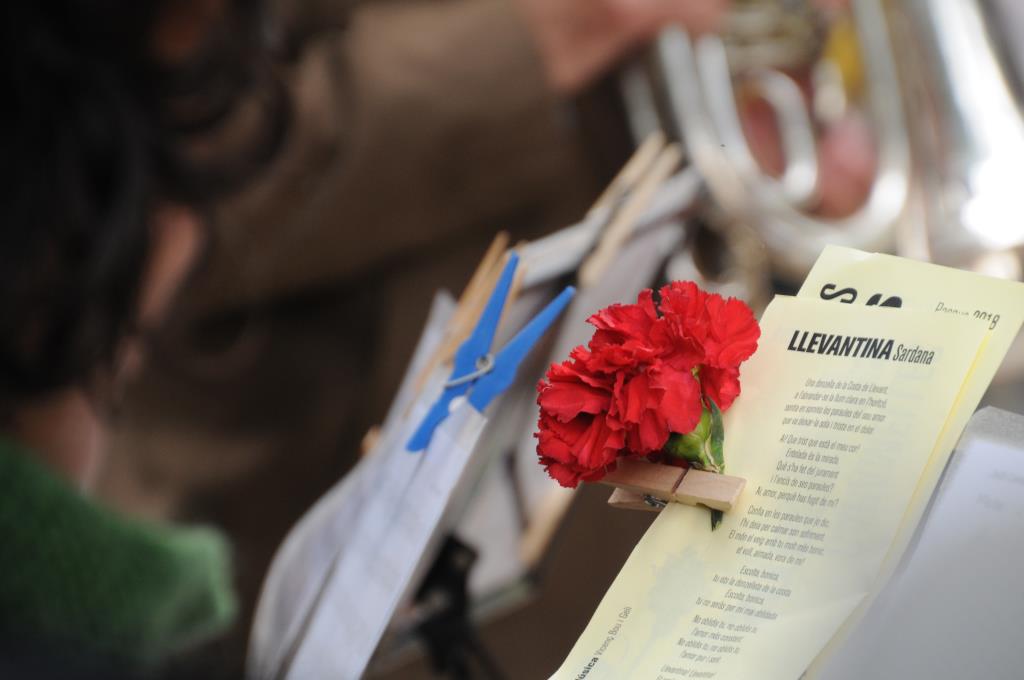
[406,253,575,452]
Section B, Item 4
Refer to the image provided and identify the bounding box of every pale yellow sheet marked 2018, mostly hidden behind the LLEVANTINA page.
[798,246,1024,677]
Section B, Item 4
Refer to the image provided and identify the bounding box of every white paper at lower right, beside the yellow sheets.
[818,421,1024,680]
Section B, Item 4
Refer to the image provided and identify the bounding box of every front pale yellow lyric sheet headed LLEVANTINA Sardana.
[553,297,989,680]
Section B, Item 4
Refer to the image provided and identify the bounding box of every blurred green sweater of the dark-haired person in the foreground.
[0,438,236,668]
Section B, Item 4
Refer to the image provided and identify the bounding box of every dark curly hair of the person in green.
[0,0,288,408]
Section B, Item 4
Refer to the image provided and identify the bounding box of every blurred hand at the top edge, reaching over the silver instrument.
[515,0,728,93]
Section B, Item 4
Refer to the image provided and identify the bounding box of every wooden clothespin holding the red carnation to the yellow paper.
[601,460,746,512]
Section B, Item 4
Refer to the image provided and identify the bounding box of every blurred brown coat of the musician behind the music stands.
[100,0,596,669]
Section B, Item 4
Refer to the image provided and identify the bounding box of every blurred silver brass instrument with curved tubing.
[626,0,1024,282]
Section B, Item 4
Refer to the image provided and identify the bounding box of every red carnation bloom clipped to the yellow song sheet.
[537,282,761,486]
